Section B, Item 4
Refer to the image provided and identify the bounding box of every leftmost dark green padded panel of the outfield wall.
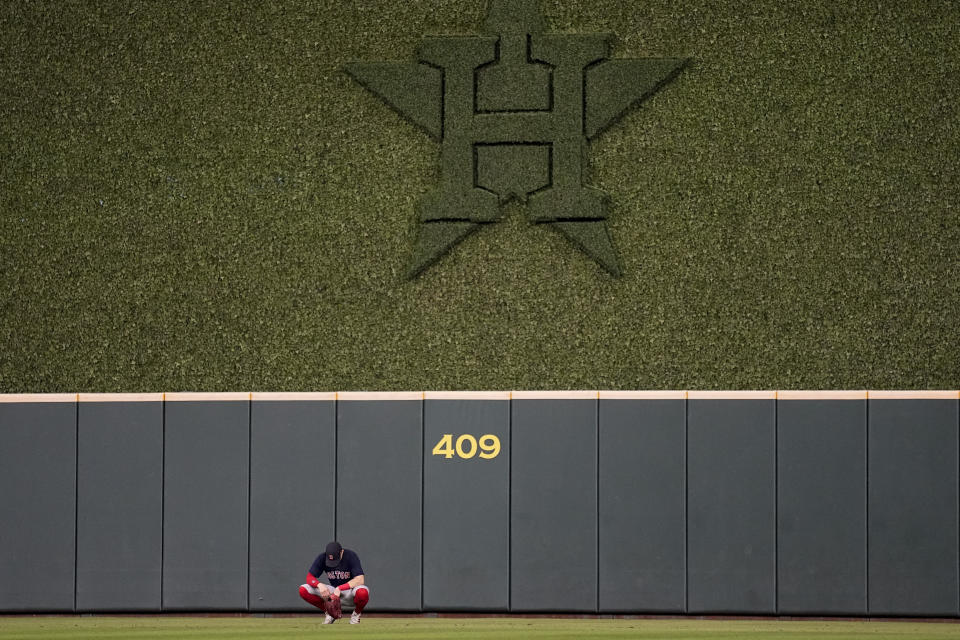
[0,402,77,611]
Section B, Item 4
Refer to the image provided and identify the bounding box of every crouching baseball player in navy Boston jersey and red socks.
[300,542,370,624]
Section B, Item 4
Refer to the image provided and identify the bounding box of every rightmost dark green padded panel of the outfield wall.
[868,399,958,616]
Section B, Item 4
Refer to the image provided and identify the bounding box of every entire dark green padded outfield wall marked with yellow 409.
[0,391,960,616]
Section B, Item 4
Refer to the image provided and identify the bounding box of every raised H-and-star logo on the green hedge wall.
[346,0,687,278]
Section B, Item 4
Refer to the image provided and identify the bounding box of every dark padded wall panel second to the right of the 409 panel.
[599,399,686,613]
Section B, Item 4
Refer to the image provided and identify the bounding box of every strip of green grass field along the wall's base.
[0,615,960,640]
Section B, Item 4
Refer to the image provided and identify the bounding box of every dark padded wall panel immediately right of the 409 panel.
[510,397,598,612]
